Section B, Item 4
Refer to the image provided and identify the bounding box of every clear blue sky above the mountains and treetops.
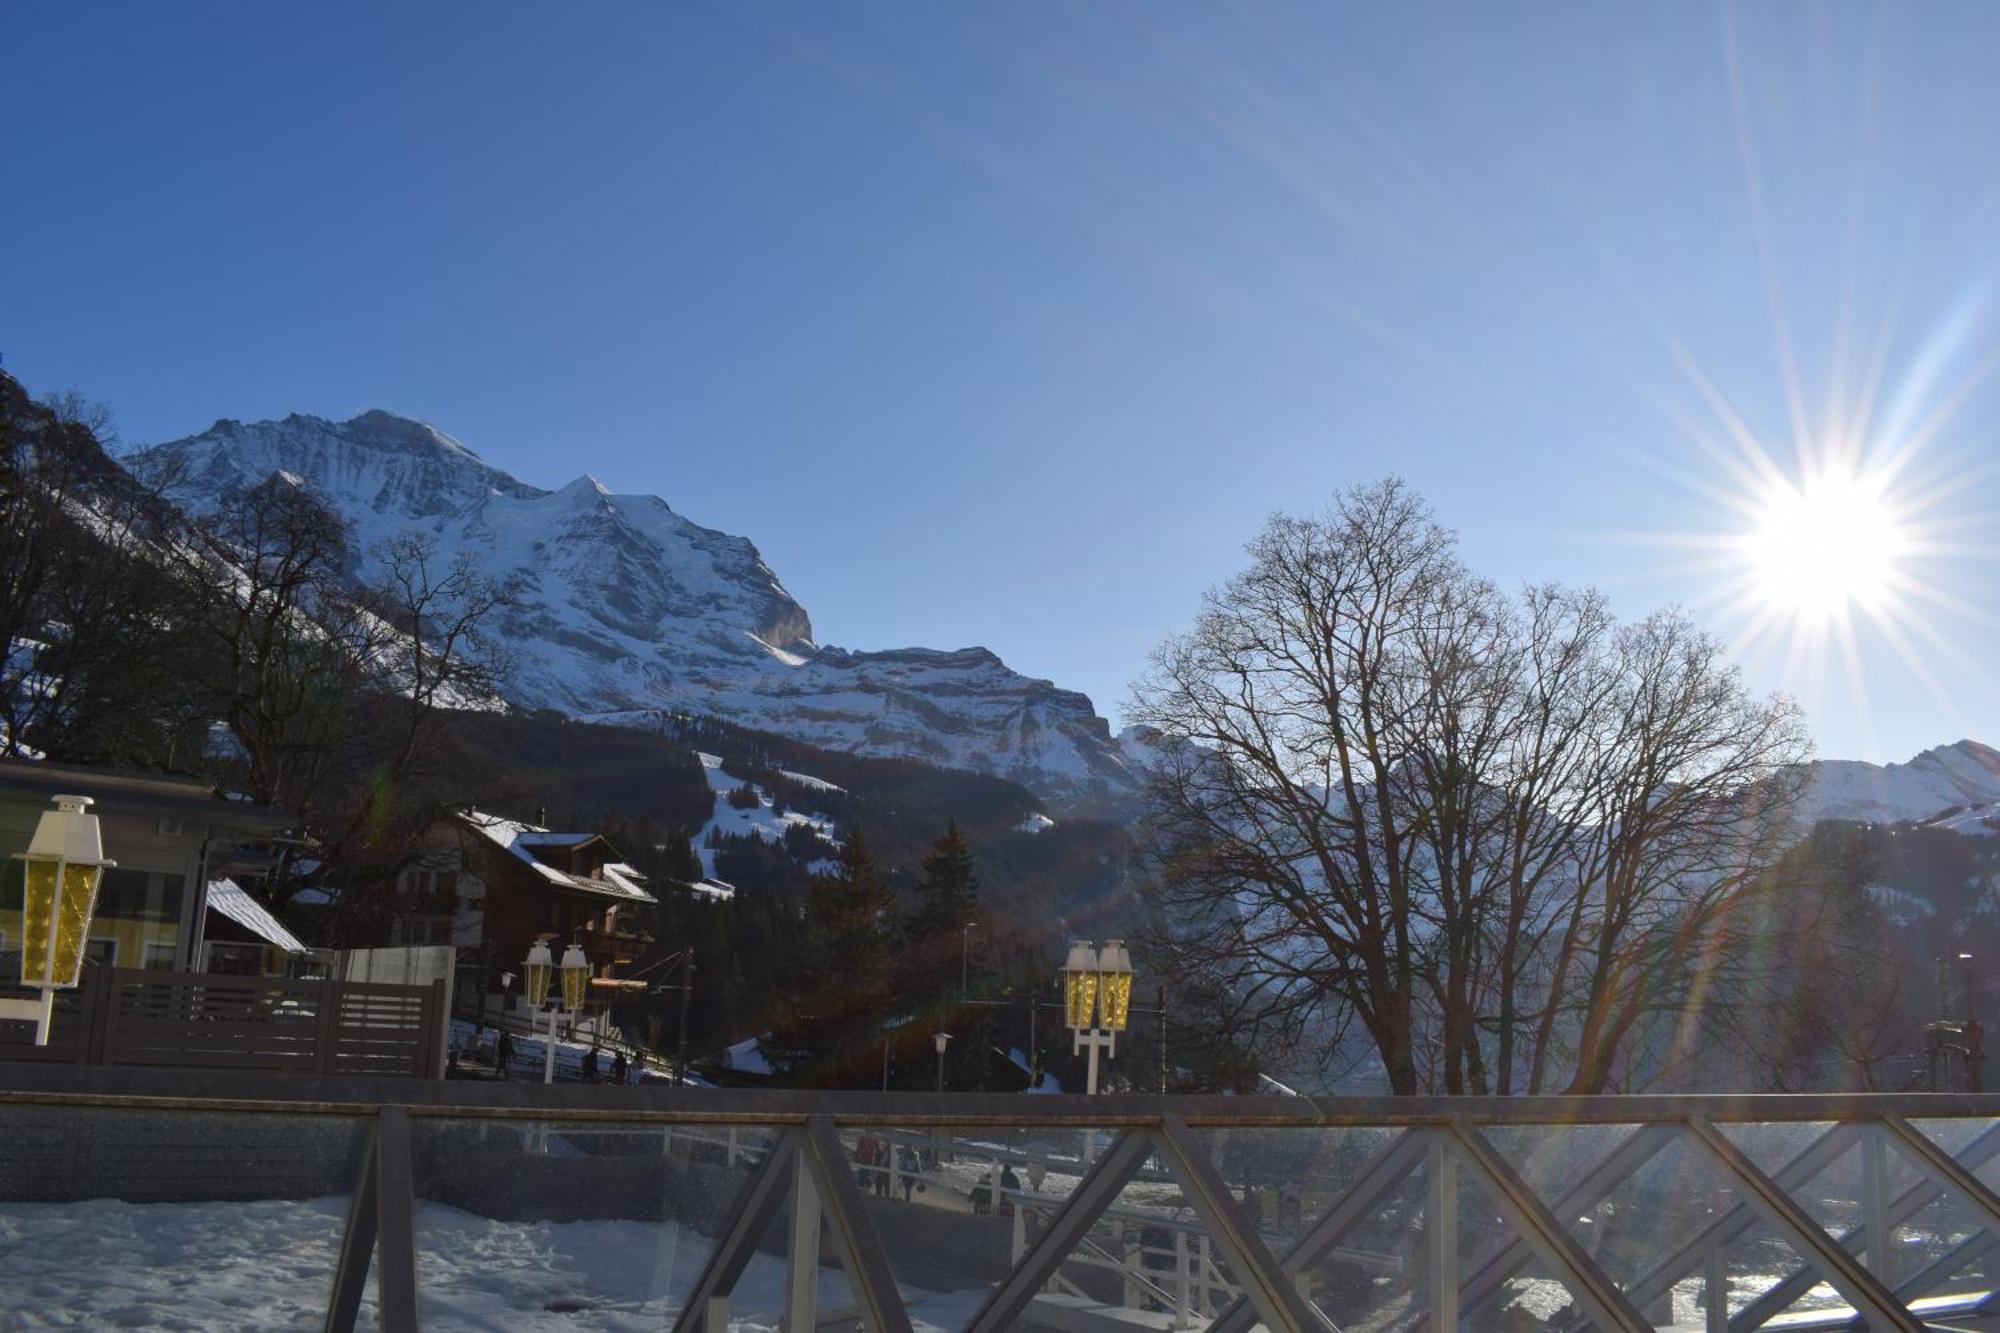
[0,2,2000,759]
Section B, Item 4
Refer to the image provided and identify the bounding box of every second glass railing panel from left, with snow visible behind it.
[410,1119,784,1331]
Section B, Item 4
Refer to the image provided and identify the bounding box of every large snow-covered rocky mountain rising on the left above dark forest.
[130,412,1136,803]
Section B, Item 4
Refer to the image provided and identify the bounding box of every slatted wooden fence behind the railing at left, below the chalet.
[0,967,444,1079]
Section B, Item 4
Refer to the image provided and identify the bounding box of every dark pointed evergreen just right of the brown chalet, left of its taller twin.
[764,829,896,1087]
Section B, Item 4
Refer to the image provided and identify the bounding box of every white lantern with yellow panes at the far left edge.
[0,797,118,1047]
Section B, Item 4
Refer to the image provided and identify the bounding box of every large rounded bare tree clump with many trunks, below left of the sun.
[1132,480,1804,1093]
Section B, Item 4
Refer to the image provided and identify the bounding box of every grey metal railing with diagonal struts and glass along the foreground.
[0,1065,2000,1333]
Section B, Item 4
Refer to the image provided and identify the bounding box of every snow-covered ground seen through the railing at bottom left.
[0,1199,986,1333]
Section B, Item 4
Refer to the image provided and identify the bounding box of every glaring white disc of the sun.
[1746,466,1910,622]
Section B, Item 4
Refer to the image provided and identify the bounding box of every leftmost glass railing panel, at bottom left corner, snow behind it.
[0,1107,366,1331]
